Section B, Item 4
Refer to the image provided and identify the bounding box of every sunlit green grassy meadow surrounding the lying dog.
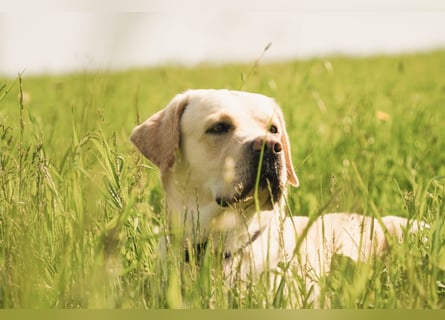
[0,51,445,309]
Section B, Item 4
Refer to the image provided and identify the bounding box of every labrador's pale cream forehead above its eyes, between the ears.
[180,90,279,121]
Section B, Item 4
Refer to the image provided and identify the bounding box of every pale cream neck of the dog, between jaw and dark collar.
[164,171,283,250]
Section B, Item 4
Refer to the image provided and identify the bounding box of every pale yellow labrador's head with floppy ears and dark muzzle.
[131,90,298,234]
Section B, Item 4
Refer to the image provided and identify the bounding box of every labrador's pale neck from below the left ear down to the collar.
[162,161,285,255]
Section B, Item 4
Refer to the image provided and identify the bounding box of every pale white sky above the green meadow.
[0,0,445,76]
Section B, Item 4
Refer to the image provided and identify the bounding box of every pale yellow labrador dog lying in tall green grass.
[131,90,424,304]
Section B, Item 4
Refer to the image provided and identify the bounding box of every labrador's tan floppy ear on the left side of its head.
[130,93,188,172]
